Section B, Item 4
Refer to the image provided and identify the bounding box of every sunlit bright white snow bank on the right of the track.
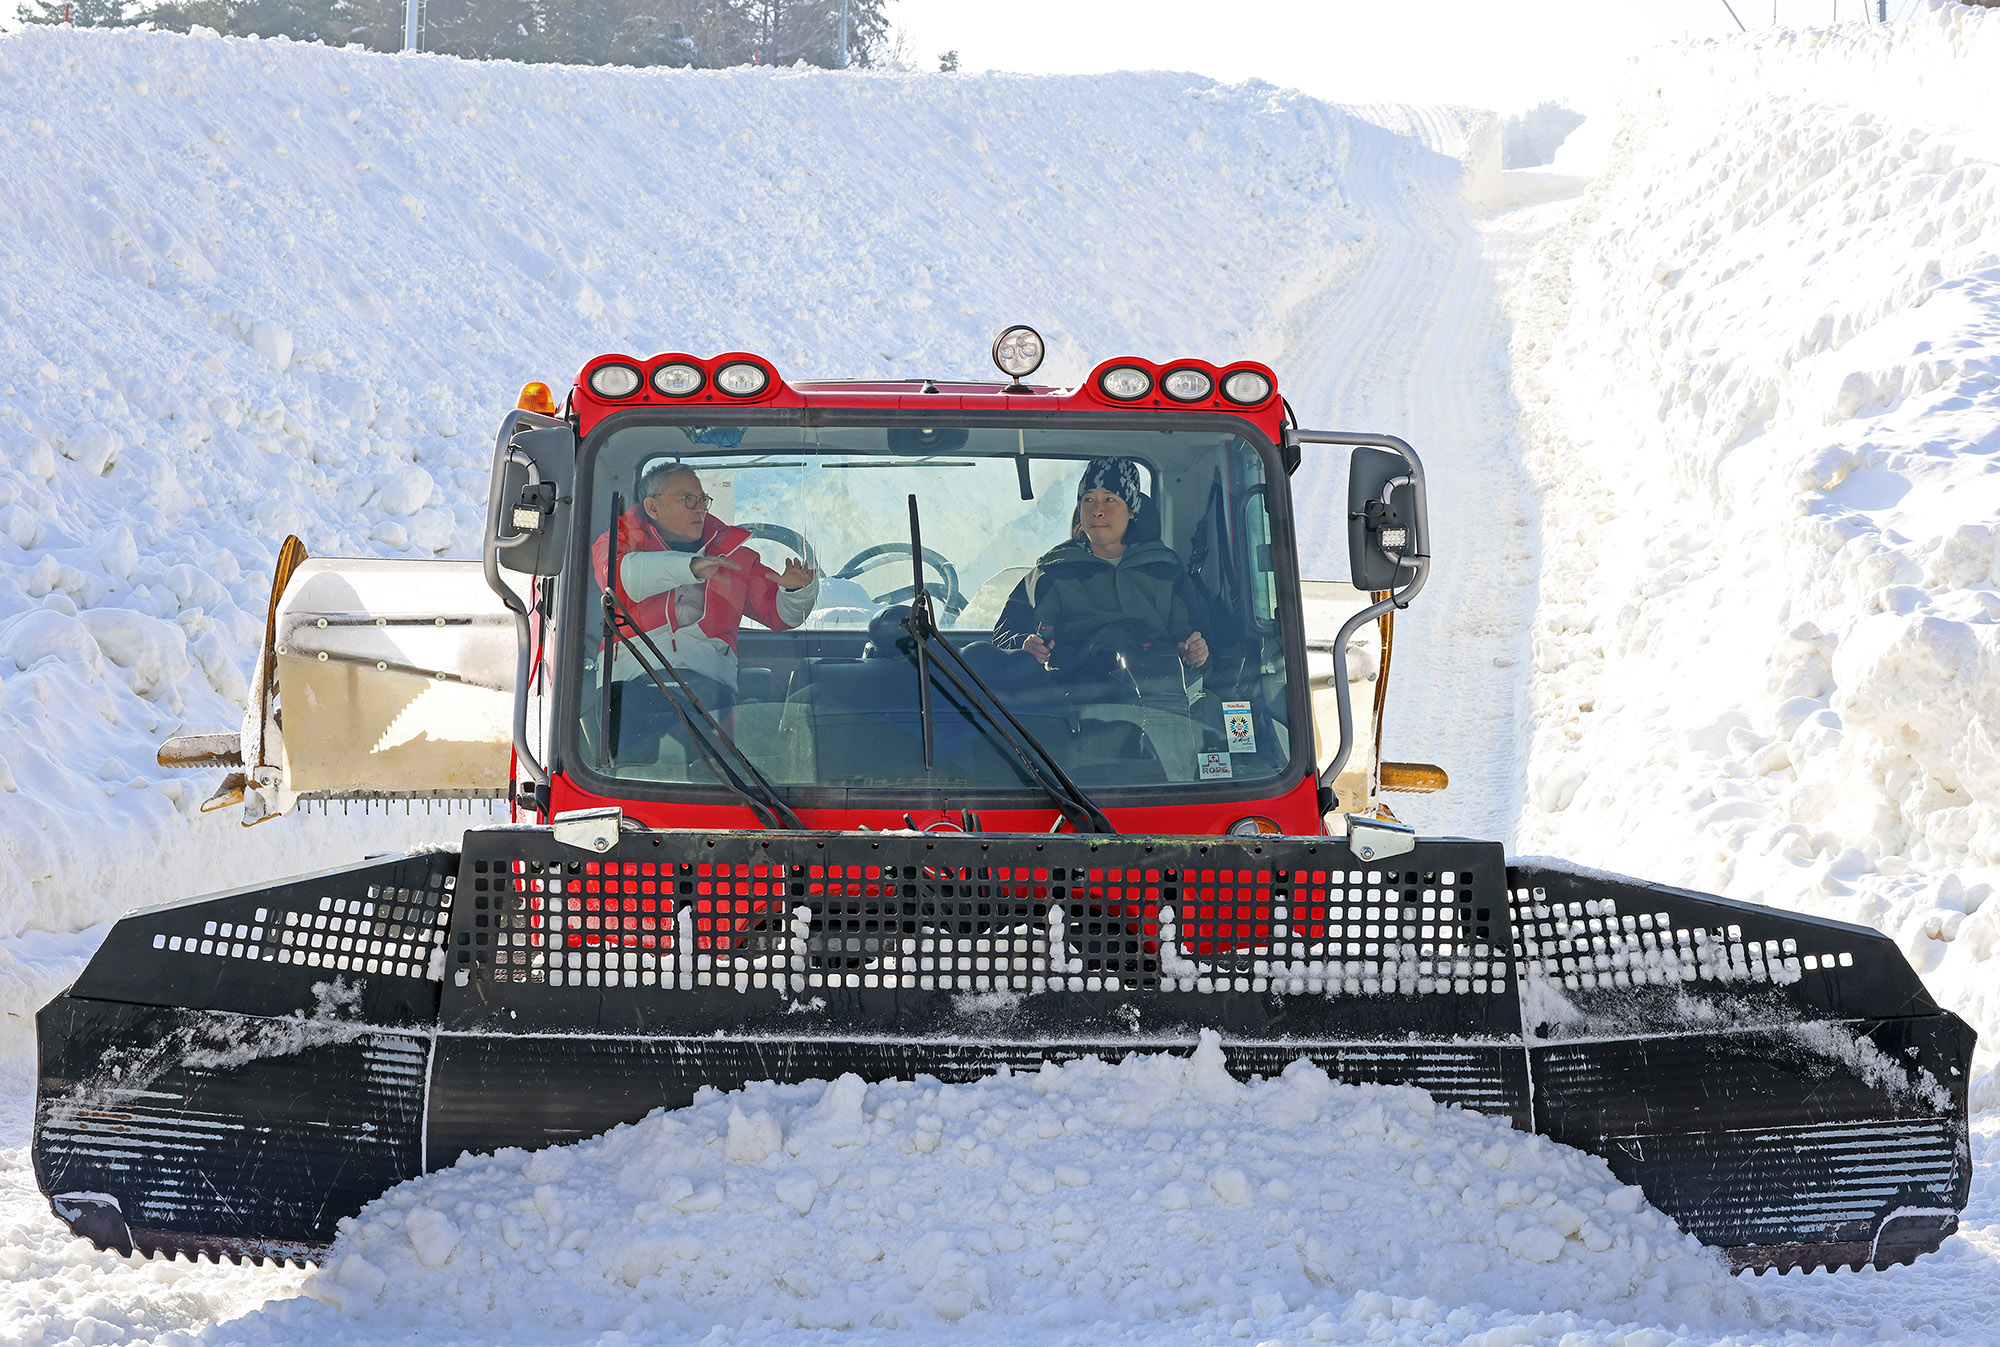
[1514,4,2000,1053]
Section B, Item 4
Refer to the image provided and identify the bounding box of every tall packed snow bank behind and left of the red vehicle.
[0,28,1388,933]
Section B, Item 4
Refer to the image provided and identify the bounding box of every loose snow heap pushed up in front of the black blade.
[215,1037,1746,1339]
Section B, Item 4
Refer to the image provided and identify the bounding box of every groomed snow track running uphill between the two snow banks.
[1284,108,1536,839]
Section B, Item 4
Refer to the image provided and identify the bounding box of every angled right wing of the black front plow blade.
[1508,863,1974,1271]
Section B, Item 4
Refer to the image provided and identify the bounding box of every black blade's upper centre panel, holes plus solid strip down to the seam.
[446,829,1520,1041]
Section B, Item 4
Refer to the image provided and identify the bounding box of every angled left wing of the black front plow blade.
[34,851,456,1259]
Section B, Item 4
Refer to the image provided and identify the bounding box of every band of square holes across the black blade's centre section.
[450,833,1510,995]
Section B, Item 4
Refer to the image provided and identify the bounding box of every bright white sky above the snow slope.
[888,0,1924,112]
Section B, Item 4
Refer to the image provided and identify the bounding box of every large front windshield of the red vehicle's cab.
[568,424,1294,795]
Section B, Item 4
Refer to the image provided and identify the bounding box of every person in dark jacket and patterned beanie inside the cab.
[994,458,1208,672]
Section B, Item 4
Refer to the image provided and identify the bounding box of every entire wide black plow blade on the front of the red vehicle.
[34,827,1972,1269]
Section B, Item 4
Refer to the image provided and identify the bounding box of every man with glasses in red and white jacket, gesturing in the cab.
[592,460,820,757]
